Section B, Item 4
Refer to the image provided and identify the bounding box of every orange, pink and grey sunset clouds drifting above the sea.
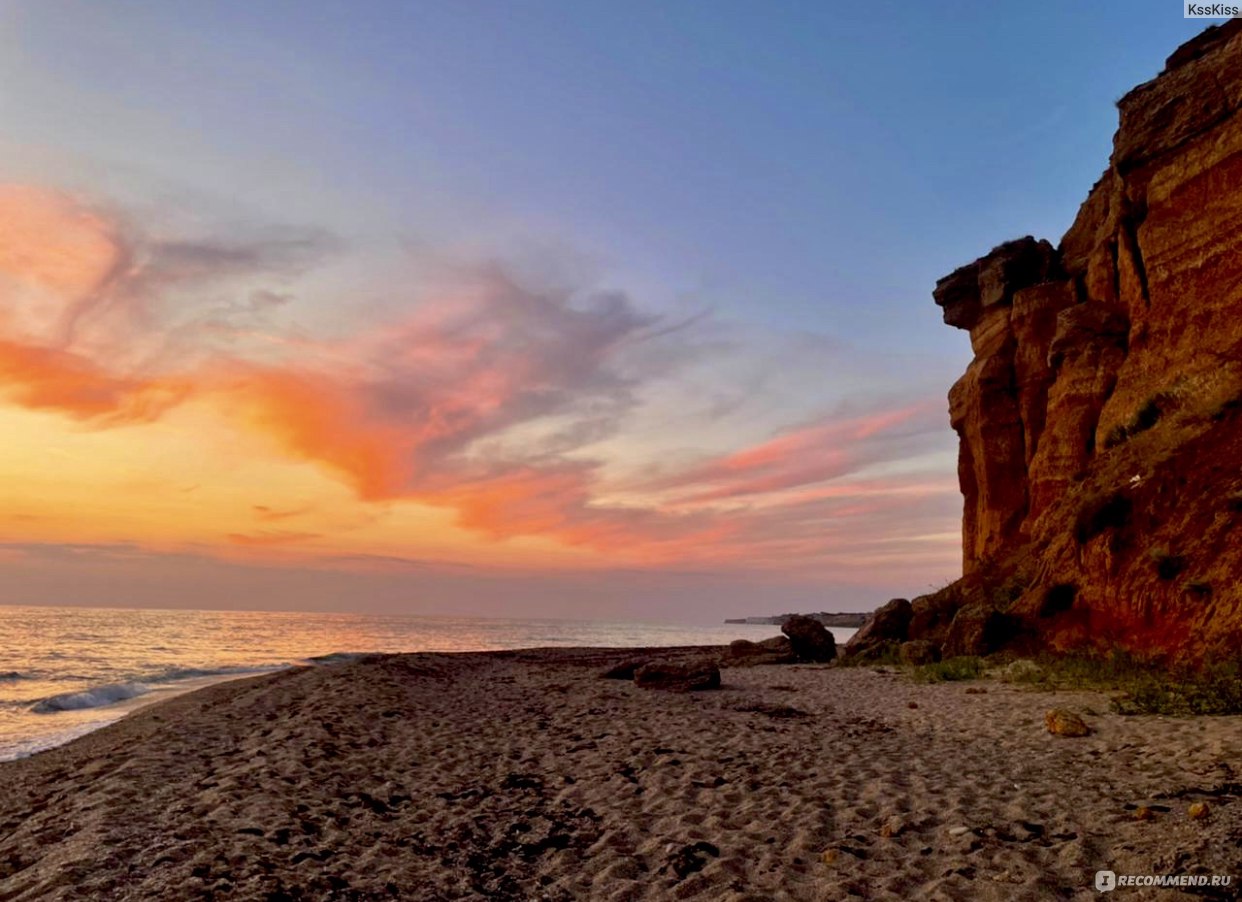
[0,186,946,578]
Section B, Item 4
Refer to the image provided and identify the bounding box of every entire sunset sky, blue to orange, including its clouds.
[0,0,1206,622]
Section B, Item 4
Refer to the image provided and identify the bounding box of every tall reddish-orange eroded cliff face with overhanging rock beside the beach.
[904,20,1242,660]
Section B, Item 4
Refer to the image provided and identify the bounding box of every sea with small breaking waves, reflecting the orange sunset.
[0,605,854,762]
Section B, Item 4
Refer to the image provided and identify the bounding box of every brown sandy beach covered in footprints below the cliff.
[0,650,1242,902]
